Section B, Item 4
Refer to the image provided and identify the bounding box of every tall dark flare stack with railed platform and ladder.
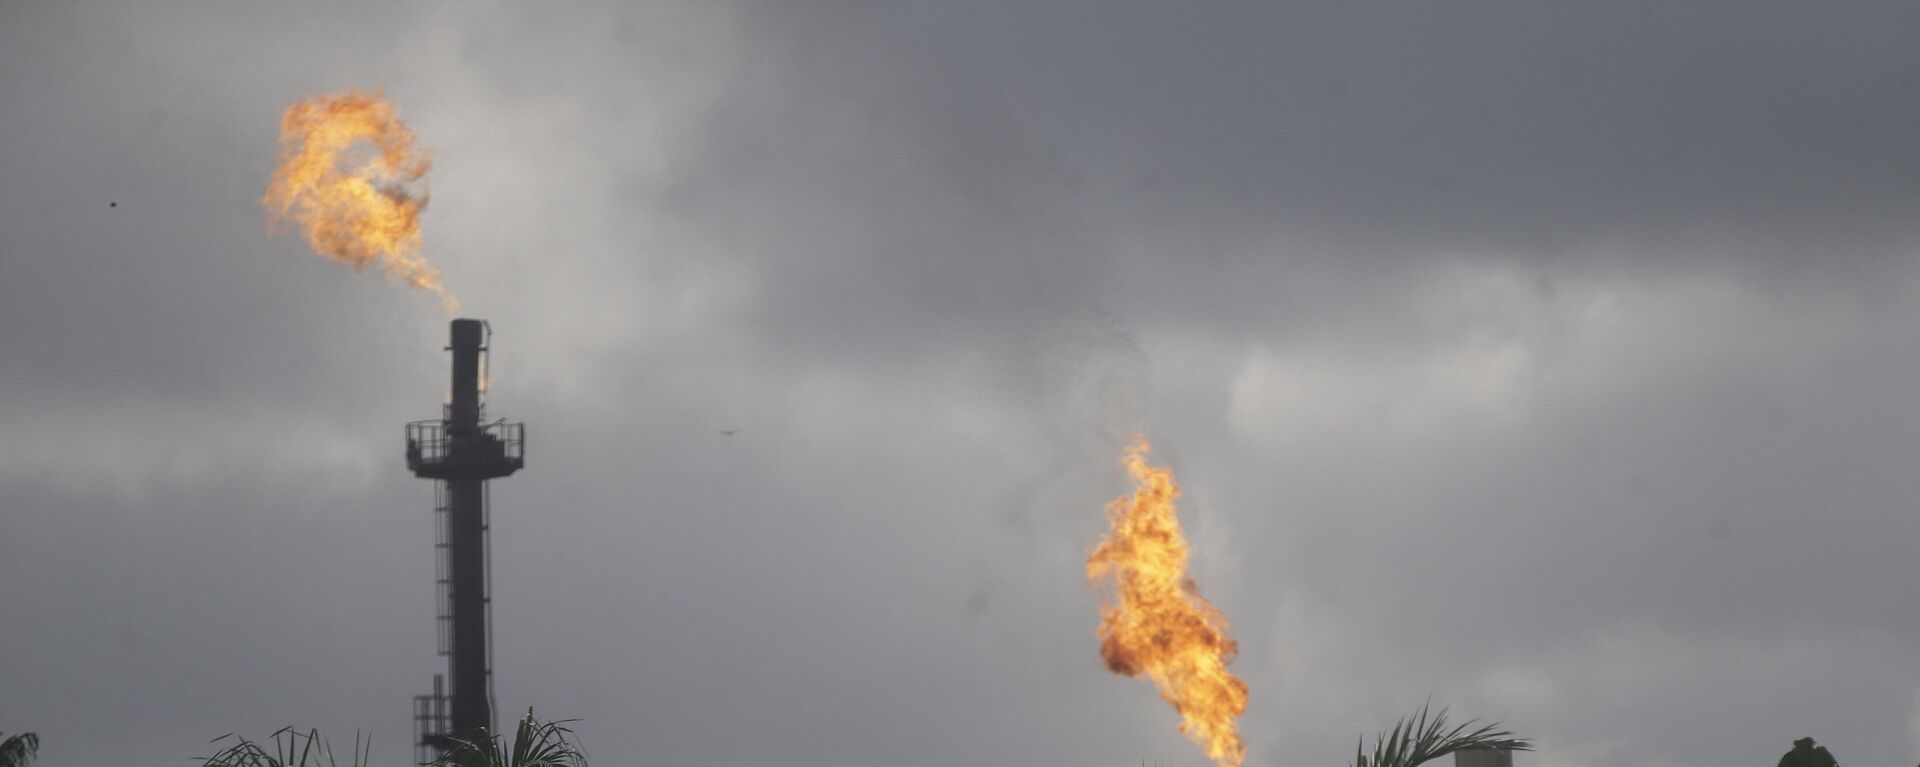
[407,319,526,761]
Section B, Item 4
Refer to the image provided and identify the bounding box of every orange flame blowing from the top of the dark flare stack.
[261,88,459,313]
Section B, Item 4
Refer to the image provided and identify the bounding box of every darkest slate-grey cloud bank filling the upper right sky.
[852,2,1920,248]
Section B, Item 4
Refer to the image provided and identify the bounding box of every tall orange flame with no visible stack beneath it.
[1087,438,1246,767]
